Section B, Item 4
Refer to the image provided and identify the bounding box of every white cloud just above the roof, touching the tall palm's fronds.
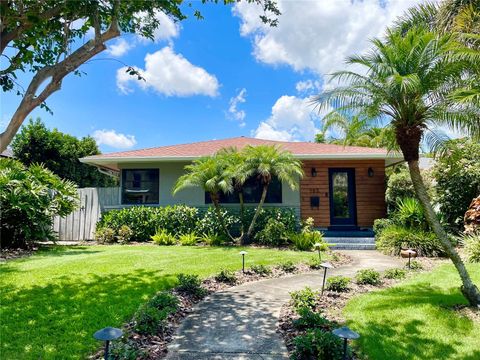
[253,95,320,141]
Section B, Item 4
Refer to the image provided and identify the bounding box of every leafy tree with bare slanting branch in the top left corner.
[0,0,280,152]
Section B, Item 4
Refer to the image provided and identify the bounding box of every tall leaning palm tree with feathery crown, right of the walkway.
[315,27,480,305]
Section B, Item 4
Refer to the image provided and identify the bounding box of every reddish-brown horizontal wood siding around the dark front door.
[300,160,385,227]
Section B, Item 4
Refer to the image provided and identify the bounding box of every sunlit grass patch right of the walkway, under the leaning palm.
[344,264,480,360]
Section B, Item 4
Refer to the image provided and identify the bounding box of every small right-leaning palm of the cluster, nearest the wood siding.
[243,145,303,239]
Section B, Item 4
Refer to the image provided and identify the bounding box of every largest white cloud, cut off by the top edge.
[233,0,420,74]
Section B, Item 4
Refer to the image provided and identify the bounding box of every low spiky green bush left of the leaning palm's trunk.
[376,225,445,256]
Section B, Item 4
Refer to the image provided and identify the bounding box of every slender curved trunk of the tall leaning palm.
[408,160,480,306]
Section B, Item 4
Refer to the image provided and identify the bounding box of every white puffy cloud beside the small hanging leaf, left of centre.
[117,46,220,96]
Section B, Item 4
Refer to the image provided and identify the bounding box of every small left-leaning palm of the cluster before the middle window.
[173,155,235,241]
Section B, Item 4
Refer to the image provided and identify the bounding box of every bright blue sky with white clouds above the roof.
[1,0,416,152]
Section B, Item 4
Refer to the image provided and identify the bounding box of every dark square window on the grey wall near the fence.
[122,169,159,204]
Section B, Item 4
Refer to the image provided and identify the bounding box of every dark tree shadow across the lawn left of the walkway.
[0,265,176,359]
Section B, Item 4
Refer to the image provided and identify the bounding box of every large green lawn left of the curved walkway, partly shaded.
[0,245,312,359]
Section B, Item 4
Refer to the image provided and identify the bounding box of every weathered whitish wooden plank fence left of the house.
[53,187,119,240]
